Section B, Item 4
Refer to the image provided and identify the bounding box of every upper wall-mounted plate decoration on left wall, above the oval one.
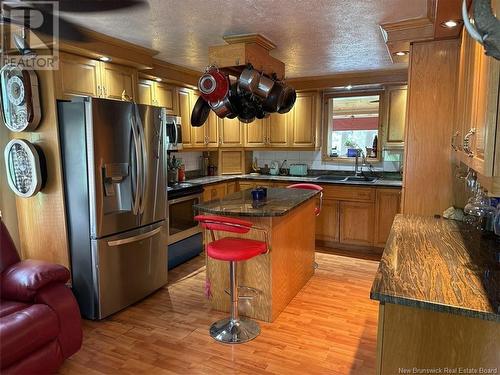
[0,64,41,132]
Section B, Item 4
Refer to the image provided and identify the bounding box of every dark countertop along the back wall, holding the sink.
[189,174,403,187]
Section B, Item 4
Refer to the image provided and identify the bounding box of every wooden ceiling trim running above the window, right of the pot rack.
[287,69,408,90]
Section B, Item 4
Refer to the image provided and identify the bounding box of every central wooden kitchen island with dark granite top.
[194,188,318,322]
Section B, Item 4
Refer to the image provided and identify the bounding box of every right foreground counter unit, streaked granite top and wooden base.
[371,215,500,374]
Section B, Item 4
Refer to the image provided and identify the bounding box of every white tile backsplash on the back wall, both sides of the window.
[253,150,403,172]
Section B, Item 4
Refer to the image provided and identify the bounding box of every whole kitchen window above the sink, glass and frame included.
[323,92,383,162]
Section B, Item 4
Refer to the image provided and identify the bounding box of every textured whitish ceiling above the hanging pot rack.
[64,0,427,78]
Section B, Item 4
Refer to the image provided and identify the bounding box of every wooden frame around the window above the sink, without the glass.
[321,88,385,164]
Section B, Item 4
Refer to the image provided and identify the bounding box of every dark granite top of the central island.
[193,188,318,217]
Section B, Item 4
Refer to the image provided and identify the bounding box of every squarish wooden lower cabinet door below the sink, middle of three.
[339,202,375,246]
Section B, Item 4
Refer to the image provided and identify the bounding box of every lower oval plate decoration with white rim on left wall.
[4,139,43,198]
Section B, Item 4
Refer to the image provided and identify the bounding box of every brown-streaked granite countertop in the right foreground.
[370,215,500,322]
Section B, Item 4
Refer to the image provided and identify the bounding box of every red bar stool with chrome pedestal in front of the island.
[194,215,269,344]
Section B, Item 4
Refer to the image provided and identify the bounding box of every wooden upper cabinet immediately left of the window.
[289,91,320,148]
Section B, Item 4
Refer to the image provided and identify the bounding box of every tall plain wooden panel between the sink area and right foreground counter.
[402,39,459,215]
